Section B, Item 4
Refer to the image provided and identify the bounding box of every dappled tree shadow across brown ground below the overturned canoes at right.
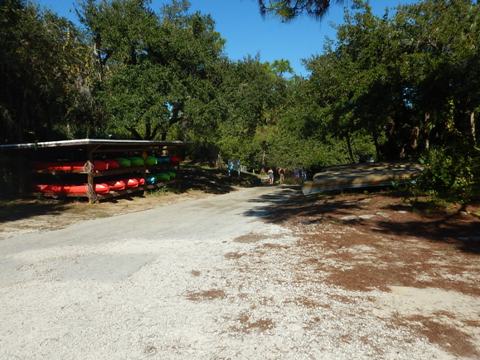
[245,187,480,254]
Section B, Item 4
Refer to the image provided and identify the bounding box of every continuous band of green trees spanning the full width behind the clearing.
[0,0,480,197]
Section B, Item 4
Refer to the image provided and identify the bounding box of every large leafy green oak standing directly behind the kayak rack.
[79,0,224,140]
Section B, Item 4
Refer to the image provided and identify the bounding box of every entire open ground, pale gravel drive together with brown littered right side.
[0,187,480,359]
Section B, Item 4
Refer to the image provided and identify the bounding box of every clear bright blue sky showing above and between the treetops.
[34,0,416,75]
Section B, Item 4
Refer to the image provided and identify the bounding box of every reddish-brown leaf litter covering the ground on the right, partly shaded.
[244,188,480,358]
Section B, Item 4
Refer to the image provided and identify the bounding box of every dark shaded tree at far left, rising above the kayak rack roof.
[0,0,95,142]
